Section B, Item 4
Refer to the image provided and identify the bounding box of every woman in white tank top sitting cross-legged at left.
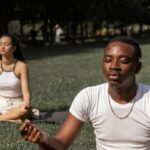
[0,34,31,122]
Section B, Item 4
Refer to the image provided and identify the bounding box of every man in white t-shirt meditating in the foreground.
[20,36,150,150]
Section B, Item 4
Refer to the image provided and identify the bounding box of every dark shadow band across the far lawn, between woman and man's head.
[22,41,106,60]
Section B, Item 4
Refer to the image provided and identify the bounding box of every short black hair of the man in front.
[109,36,142,59]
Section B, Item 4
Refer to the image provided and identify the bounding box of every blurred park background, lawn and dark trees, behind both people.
[0,0,150,150]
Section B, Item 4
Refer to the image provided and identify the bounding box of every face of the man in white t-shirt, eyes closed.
[103,42,139,87]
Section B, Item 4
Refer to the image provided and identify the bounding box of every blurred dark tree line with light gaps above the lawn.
[0,0,150,46]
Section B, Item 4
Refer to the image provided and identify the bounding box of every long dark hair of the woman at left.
[0,34,25,61]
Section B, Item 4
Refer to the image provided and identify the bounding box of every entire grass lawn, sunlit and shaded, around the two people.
[0,40,150,150]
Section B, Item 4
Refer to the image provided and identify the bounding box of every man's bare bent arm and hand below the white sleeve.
[20,114,84,150]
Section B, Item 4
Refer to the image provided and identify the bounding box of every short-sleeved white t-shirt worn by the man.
[70,83,150,150]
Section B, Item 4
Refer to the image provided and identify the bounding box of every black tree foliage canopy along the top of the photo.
[0,0,150,38]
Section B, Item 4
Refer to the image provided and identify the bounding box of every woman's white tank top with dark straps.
[0,63,22,98]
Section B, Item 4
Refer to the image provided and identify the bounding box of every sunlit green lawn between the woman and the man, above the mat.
[29,44,101,110]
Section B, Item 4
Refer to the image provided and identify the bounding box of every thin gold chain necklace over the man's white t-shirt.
[108,94,136,119]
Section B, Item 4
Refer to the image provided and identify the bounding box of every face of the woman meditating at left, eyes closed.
[0,36,16,56]
